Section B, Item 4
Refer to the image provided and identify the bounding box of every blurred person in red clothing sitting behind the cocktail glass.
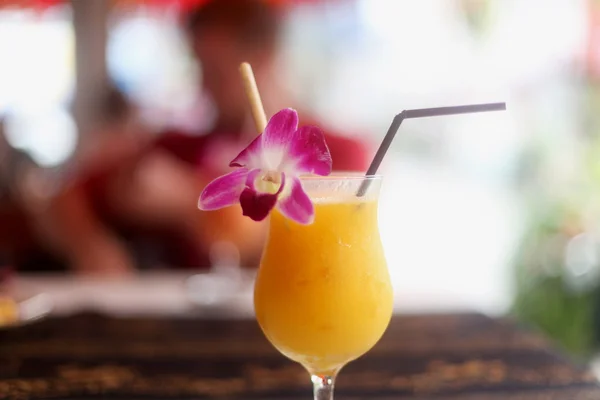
[34,0,368,275]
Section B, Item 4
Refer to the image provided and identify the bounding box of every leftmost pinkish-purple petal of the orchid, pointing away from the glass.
[198,168,249,211]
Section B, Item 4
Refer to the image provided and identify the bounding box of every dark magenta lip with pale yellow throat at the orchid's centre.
[240,169,285,221]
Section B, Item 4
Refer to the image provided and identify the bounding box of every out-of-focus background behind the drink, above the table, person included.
[0,0,600,358]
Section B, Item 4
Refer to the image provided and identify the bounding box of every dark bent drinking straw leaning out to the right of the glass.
[356,103,506,197]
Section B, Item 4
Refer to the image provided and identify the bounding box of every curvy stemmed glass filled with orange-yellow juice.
[254,175,393,400]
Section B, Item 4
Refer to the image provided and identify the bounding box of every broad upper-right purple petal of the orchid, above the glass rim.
[281,126,332,175]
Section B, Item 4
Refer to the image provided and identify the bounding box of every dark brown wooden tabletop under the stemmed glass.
[0,314,600,400]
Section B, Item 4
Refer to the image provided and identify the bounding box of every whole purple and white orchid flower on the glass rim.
[198,108,331,224]
